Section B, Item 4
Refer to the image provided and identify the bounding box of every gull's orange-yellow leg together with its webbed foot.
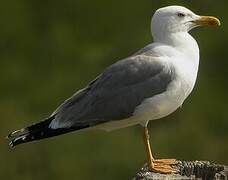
[143,127,176,174]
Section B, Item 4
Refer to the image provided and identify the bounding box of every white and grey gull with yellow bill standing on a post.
[8,6,220,173]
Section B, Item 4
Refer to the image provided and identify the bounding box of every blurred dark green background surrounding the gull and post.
[0,0,228,180]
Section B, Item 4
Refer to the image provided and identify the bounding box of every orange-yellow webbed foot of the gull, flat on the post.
[149,159,177,174]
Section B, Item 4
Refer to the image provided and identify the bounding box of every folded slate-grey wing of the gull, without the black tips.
[50,55,174,128]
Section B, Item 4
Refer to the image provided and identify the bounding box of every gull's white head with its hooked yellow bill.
[151,6,220,39]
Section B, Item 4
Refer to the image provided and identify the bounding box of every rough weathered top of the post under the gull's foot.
[133,161,228,180]
